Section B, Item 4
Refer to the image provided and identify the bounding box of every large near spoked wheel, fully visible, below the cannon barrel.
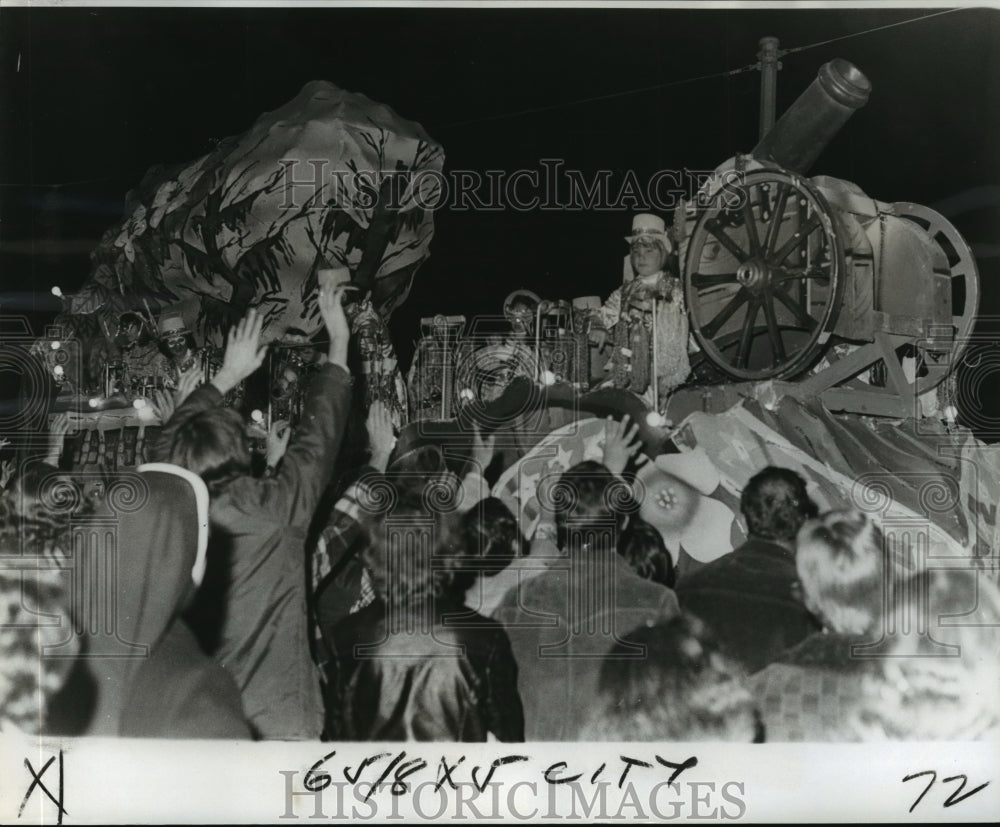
[684,170,844,381]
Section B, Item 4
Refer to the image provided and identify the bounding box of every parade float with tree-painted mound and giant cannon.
[21,60,1000,576]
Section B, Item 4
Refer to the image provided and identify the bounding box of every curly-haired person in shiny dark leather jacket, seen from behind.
[322,488,524,741]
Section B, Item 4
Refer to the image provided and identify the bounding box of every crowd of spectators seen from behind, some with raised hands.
[0,288,1000,742]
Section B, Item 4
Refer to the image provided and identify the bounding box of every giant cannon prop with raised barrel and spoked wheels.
[675,59,979,417]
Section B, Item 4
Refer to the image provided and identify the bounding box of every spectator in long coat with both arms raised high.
[165,286,351,739]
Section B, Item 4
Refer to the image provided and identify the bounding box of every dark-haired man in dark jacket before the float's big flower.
[676,466,820,675]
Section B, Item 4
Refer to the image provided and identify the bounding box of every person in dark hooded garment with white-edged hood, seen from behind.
[44,463,252,739]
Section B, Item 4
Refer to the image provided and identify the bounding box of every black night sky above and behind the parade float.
[0,3,1000,366]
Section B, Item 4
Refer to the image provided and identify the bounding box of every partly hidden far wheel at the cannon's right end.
[892,202,979,394]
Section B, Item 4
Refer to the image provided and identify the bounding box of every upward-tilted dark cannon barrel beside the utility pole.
[750,58,872,173]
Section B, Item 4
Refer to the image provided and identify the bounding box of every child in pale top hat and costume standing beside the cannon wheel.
[595,213,691,410]
